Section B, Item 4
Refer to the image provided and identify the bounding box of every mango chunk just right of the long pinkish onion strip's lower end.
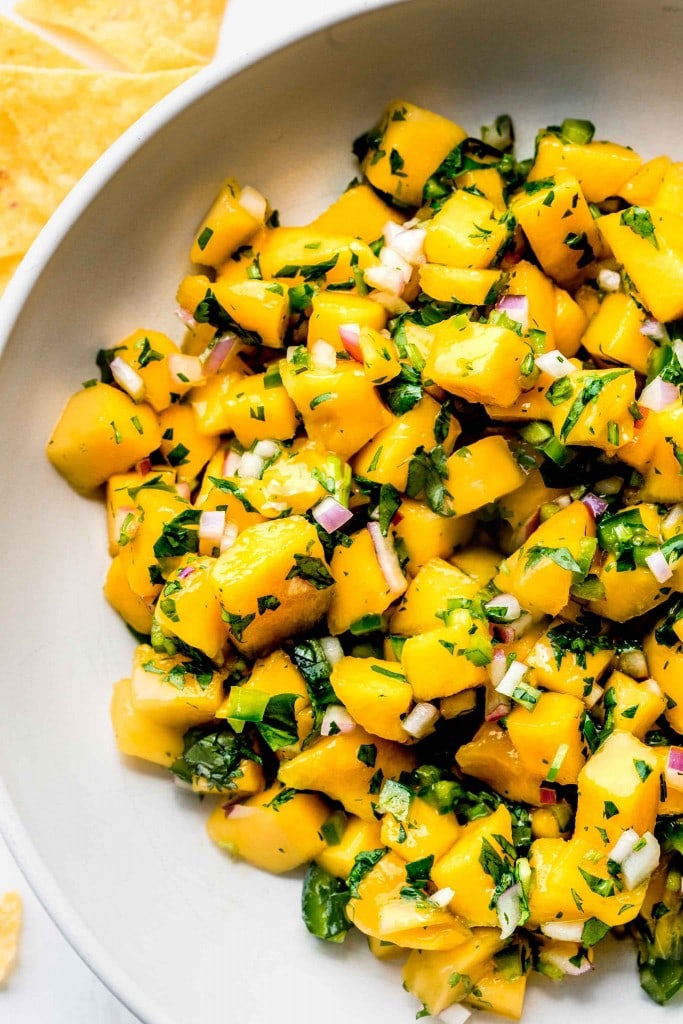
[389,558,481,637]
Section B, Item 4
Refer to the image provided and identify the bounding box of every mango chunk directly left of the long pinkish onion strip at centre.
[328,529,408,636]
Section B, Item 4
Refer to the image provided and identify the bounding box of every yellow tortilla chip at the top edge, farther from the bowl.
[14,0,225,72]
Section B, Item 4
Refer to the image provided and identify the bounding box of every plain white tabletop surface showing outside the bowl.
[0,0,387,1024]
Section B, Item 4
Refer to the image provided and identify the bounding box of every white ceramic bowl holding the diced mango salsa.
[0,0,683,1024]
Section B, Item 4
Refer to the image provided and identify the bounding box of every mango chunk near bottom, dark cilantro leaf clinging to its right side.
[431,804,512,928]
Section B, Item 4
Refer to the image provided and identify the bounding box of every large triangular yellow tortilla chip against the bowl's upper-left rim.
[0,67,197,258]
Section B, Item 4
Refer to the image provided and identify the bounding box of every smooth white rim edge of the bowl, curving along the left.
[0,0,409,1024]
